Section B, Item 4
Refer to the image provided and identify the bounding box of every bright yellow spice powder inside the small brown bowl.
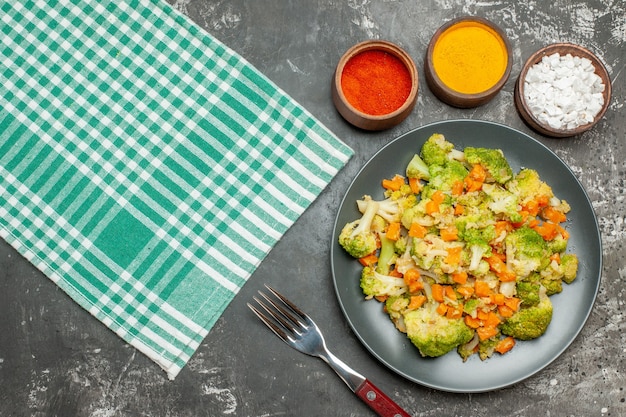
[432,21,508,94]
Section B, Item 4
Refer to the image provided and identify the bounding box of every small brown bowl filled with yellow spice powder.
[424,16,512,108]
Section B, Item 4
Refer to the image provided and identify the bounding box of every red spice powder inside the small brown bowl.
[341,50,412,116]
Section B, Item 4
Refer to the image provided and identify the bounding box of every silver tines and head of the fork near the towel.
[248,285,308,341]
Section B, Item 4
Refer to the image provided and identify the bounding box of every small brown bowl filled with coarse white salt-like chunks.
[514,43,611,138]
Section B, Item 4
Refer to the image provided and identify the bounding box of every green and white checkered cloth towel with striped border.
[0,0,352,379]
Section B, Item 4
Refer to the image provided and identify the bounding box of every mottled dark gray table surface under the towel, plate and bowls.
[0,0,626,417]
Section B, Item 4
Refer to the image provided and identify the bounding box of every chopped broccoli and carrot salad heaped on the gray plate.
[339,134,578,360]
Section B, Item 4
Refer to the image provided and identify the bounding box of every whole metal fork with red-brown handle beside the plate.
[248,285,410,417]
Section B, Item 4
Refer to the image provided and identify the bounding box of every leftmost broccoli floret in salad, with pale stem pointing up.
[339,196,379,258]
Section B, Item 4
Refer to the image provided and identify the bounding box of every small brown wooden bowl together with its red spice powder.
[332,40,418,130]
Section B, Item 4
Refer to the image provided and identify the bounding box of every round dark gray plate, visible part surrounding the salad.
[331,120,602,393]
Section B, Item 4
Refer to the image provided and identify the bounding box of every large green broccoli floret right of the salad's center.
[504,226,550,277]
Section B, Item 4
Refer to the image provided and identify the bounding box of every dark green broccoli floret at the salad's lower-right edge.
[500,293,552,340]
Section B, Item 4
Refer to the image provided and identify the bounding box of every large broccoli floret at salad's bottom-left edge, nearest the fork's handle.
[404,302,474,357]
